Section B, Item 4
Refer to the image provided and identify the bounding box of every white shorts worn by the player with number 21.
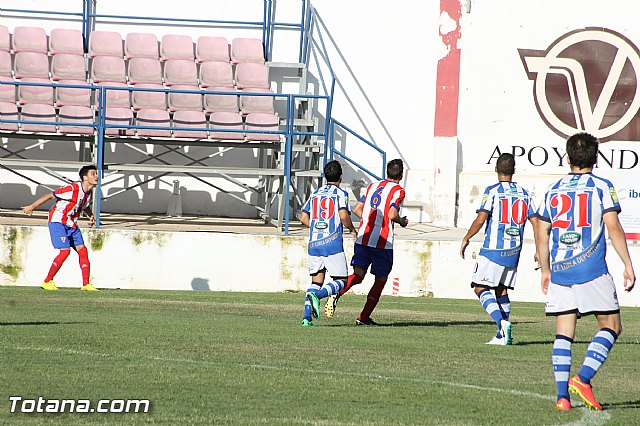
[545,274,620,316]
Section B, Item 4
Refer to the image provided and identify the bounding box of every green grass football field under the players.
[0,287,640,425]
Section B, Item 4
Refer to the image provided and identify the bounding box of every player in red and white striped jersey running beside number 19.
[325,159,409,326]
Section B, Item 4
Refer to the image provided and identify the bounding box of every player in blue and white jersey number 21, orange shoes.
[536,133,636,411]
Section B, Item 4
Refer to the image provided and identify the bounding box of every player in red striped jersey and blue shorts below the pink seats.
[22,165,98,291]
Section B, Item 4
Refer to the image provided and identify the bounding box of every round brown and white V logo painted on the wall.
[518,28,640,142]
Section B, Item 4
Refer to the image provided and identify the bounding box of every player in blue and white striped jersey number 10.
[460,154,538,345]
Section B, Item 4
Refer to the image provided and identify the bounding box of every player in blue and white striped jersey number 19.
[300,161,356,326]
